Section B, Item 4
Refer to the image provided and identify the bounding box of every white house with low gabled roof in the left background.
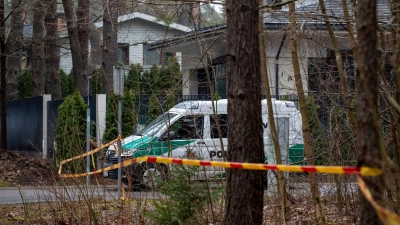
[60,12,190,73]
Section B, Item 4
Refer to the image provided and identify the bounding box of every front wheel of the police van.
[137,163,168,190]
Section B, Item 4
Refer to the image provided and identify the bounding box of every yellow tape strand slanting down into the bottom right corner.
[357,176,400,225]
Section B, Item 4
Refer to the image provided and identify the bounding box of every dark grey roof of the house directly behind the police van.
[150,0,391,49]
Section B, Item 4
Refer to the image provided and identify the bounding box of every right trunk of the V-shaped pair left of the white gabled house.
[76,0,91,78]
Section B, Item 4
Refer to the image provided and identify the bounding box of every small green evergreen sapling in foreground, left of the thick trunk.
[145,165,222,225]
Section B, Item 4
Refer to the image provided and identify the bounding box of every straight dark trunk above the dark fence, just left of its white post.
[32,0,45,96]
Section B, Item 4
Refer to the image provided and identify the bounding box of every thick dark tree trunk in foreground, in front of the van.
[223,0,264,225]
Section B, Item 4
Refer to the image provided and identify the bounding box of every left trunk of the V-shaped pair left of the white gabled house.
[62,0,86,95]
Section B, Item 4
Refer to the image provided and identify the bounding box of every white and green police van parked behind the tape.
[103,99,304,186]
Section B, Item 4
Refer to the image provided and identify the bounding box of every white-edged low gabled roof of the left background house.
[94,12,190,32]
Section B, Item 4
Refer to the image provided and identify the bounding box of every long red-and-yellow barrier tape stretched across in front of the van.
[59,156,382,178]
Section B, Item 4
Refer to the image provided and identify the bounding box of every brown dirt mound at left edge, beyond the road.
[0,151,116,187]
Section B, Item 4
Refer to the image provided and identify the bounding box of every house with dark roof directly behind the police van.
[151,0,390,96]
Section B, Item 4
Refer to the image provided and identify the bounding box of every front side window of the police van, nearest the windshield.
[170,115,204,139]
